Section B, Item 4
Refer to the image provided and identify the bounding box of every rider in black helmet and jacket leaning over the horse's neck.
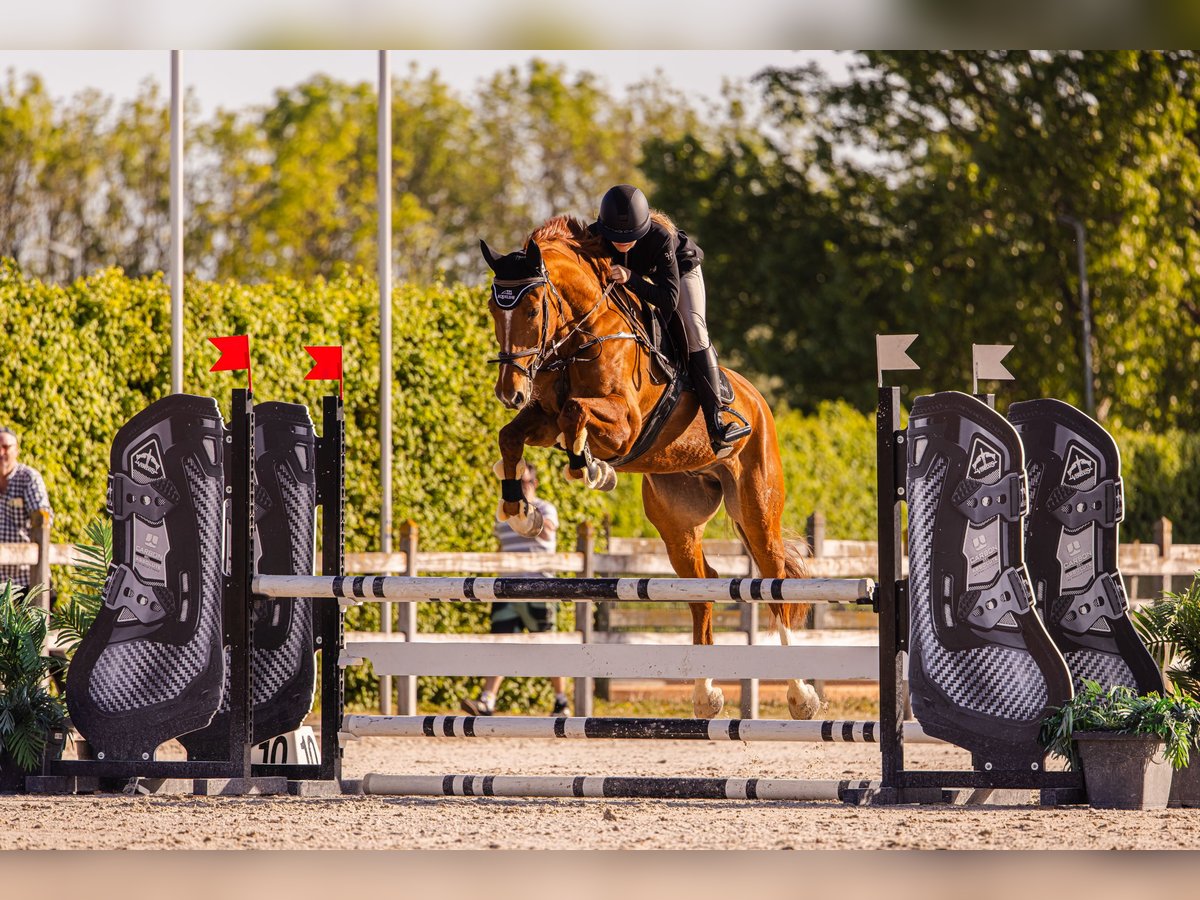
[590,185,750,458]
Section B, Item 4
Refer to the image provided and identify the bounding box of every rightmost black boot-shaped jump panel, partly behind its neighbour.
[1008,400,1163,694]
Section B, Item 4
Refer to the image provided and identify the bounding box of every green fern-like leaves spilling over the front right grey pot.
[1040,680,1200,770]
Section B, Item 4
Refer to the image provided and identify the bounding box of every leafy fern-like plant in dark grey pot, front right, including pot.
[1040,680,1200,809]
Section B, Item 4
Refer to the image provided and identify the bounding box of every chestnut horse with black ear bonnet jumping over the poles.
[480,216,820,719]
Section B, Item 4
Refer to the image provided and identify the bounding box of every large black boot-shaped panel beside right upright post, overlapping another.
[907,392,1072,772]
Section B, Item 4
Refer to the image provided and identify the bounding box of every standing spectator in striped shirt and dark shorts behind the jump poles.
[461,464,571,716]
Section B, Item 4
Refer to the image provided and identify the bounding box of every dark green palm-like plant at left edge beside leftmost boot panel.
[0,582,66,792]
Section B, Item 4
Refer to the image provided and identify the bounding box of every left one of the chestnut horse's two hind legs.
[642,474,725,719]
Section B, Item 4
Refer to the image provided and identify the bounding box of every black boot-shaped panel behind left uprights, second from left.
[179,402,317,760]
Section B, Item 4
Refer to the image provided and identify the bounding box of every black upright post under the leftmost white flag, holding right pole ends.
[875,388,908,803]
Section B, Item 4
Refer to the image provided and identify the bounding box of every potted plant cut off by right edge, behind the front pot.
[1133,576,1200,806]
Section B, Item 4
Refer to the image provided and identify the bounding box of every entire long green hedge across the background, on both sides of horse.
[0,260,1200,703]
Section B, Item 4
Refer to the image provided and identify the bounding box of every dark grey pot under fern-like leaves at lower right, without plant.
[1073,731,1172,809]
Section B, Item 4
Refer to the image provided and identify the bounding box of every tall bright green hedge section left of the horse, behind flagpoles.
[0,260,608,715]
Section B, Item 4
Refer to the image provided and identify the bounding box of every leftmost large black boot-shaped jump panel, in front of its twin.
[67,395,226,760]
